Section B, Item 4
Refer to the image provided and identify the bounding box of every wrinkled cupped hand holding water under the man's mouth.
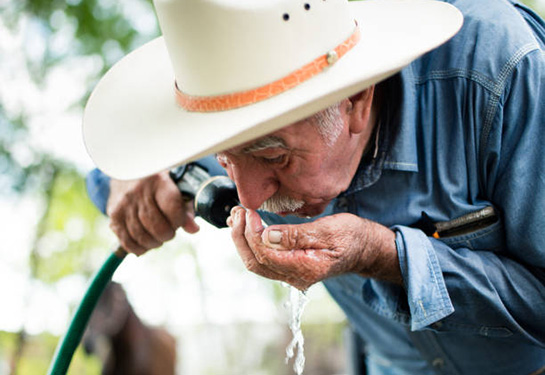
[228,207,401,290]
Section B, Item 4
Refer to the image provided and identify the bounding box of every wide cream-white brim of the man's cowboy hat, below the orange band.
[83,0,463,180]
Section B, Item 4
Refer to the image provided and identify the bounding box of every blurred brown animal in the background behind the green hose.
[83,282,176,375]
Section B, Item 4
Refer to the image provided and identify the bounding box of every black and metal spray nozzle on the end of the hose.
[170,163,239,228]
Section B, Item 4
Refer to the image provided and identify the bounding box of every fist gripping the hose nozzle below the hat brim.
[106,171,199,255]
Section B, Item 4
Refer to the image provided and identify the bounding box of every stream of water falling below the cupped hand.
[285,286,308,375]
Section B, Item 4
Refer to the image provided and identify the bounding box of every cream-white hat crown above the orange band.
[154,0,355,96]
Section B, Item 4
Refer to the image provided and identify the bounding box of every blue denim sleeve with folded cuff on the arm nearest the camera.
[393,50,545,346]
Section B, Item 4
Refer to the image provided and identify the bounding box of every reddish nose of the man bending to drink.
[221,155,279,210]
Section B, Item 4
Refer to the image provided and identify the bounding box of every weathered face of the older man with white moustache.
[217,100,374,216]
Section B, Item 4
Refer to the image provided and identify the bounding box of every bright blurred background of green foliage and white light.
[0,0,545,375]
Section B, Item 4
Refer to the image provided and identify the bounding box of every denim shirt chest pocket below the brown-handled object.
[439,218,505,253]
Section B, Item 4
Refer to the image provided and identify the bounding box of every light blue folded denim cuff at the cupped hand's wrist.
[392,226,454,331]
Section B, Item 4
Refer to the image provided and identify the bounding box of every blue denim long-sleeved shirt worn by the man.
[88,0,545,375]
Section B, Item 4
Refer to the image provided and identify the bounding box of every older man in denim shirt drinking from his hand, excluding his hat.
[84,0,545,374]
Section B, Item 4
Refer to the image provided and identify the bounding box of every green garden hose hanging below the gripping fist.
[47,247,127,375]
